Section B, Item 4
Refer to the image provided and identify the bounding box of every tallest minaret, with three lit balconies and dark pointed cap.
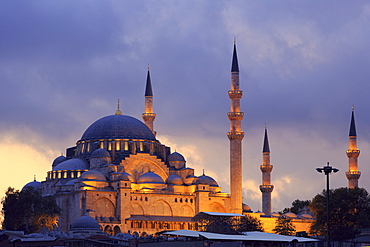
[227,42,244,214]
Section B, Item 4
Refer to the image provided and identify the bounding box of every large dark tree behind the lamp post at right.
[309,188,370,240]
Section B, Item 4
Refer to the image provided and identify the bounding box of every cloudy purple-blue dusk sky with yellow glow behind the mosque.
[0,0,370,211]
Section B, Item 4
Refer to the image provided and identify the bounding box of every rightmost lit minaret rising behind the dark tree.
[346,107,361,189]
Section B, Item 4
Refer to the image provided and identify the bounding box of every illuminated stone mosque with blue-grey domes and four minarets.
[21,44,359,235]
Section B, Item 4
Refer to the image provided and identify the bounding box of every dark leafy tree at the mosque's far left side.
[2,187,60,233]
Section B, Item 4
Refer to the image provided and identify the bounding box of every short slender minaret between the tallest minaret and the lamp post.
[260,127,274,216]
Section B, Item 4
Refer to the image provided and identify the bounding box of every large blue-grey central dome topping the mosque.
[81,115,156,141]
